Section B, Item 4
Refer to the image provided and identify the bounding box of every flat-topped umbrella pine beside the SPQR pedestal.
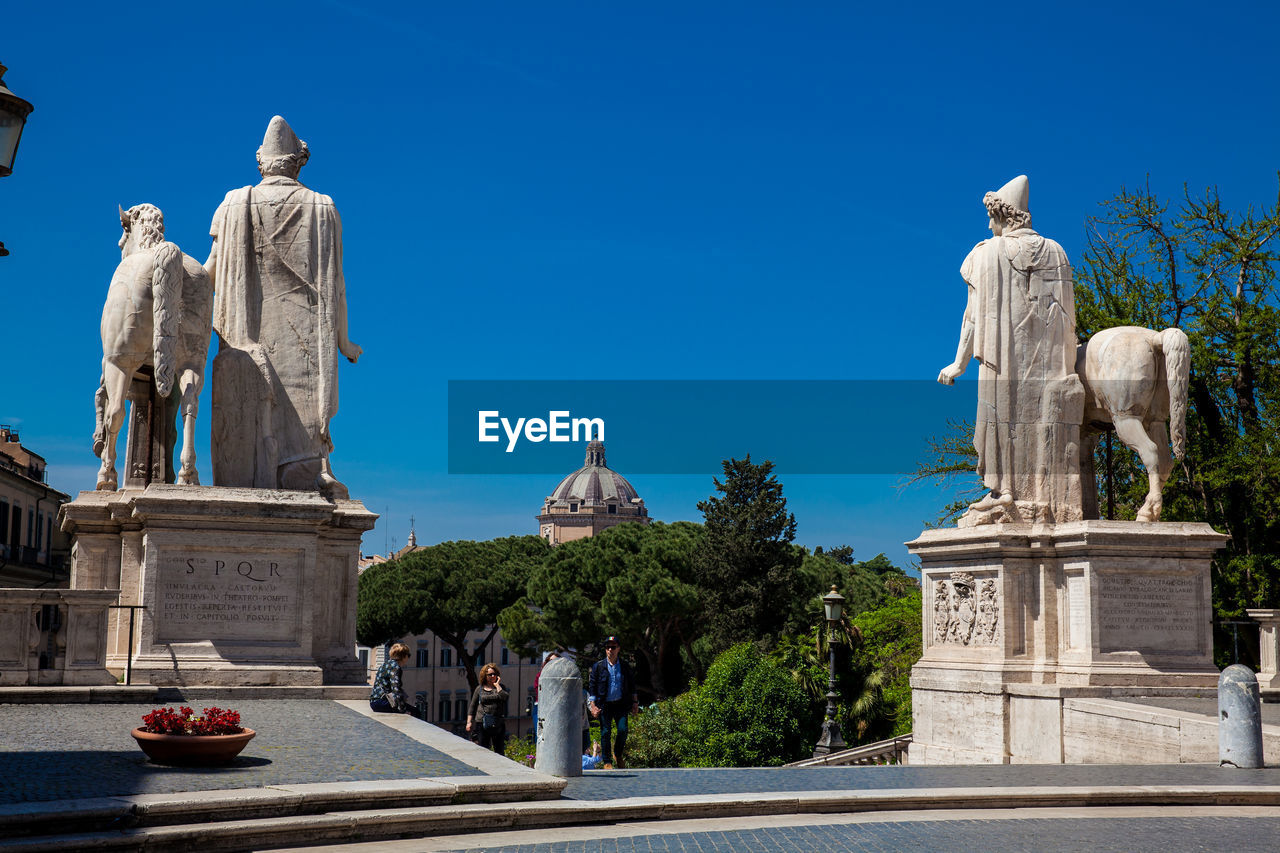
[356,537,548,690]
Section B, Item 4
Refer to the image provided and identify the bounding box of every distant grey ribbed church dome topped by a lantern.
[538,441,649,546]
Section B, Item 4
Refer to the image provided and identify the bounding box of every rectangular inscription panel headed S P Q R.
[155,548,302,643]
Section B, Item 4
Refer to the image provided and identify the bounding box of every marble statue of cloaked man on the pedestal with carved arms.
[938,175,1084,526]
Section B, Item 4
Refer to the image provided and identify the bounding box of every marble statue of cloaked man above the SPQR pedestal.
[205,115,361,498]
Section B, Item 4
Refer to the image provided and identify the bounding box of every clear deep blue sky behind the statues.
[0,0,1280,562]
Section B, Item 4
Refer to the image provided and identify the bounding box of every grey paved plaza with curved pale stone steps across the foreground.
[0,699,1280,853]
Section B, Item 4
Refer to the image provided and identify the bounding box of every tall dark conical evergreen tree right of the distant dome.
[696,455,808,652]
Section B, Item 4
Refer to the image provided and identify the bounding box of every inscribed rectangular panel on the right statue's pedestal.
[1097,574,1202,652]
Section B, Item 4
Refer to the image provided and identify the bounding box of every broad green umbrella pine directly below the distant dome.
[498,521,703,699]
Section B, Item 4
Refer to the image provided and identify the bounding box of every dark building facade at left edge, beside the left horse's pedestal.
[0,424,70,588]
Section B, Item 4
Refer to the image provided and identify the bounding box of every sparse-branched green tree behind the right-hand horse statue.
[1075,179,1280,639]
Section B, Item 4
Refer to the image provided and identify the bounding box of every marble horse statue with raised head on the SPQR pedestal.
[93,204,214,489]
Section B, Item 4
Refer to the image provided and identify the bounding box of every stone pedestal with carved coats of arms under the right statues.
[908,521,1228,763]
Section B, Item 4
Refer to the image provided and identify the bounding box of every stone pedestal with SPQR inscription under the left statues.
[61,483,378,686]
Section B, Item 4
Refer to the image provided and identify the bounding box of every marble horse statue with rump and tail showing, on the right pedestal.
[1075,325,1190,521]
